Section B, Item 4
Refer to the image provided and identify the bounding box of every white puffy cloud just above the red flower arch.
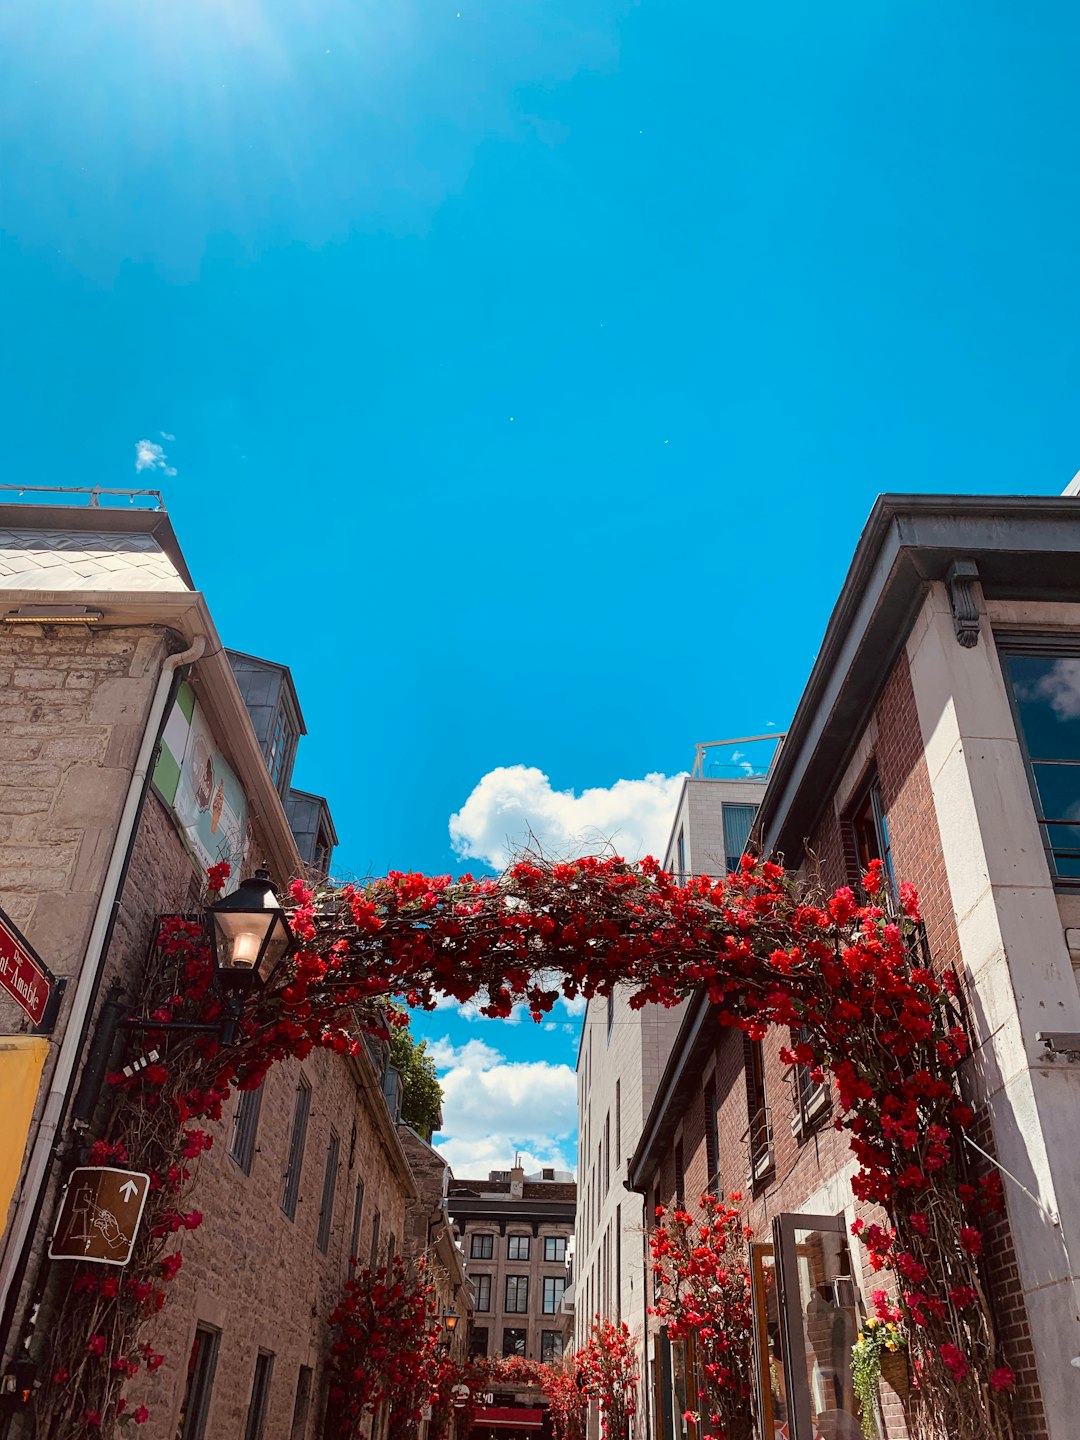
[449,765,683,870]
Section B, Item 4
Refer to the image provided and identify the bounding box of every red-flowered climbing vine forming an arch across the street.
[37,857,1014,1440]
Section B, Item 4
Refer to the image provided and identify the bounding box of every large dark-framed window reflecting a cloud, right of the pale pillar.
[1001,641,1080,880]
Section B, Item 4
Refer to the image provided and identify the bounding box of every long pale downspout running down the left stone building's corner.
[0,635,206,1335]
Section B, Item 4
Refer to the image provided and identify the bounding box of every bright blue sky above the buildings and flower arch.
[0,0,1080,1169]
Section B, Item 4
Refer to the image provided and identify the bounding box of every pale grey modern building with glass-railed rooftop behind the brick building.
[573,771,776,1428]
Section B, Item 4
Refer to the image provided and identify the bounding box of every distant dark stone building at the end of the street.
[449,1166,577,1361]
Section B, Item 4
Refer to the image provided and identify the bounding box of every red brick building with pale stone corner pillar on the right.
[629,497,1080,1440]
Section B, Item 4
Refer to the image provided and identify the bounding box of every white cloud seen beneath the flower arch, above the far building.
[428,1038,577,1176]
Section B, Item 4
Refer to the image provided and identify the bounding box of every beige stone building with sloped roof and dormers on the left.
[0,504,418,1440]
